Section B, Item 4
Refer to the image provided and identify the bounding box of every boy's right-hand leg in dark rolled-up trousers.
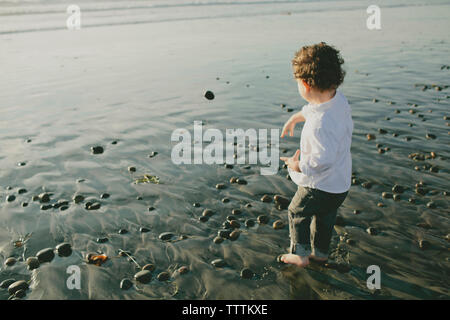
[311,190,348,260]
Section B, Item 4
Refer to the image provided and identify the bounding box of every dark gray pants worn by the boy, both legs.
[288,186,348,258]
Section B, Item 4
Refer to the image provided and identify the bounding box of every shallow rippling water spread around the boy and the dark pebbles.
[0,1,450,299]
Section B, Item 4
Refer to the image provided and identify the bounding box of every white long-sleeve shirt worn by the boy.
[289,90,353,193]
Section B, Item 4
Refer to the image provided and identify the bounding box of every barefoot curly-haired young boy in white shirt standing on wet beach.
[280,42,353,267]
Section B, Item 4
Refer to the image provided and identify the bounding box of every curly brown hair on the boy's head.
[292,42,345,91]
